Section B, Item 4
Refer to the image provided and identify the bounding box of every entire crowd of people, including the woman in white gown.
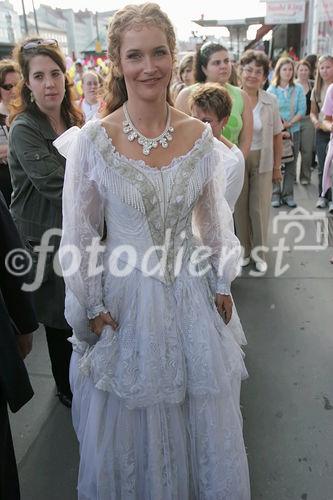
[0,3,333,500]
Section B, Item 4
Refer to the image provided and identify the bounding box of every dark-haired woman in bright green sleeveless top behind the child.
[175,42,253,158]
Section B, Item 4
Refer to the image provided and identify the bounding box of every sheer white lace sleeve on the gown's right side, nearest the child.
[193,148,241,295]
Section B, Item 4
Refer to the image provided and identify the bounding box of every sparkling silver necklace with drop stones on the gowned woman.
[123,102,174,156]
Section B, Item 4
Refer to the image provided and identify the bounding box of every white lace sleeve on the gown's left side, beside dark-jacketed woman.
[56,127,105,319]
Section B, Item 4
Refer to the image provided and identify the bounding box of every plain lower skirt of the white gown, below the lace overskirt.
[70,353,250,500]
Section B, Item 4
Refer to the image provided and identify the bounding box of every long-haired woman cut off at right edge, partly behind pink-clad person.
[310,55,333,208]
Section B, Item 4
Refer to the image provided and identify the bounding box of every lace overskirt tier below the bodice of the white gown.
[67,271,247,408]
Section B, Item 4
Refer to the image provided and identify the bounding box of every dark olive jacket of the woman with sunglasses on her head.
[8,111,69,329]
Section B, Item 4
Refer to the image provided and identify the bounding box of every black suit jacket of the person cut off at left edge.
[0,195,38,412]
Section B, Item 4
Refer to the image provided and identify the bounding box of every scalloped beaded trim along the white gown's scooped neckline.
[94,120,213,174]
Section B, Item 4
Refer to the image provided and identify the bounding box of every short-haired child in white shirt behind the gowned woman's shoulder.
[190,83,245,212]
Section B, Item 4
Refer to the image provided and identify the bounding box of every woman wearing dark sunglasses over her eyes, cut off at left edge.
[0,59,20,207]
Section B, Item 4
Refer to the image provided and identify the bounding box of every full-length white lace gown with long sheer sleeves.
[56,121,250,500]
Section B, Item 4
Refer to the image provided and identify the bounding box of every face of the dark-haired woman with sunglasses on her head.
[27,55,65,114]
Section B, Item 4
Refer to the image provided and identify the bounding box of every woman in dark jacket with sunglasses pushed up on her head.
[8,38,83,406]
